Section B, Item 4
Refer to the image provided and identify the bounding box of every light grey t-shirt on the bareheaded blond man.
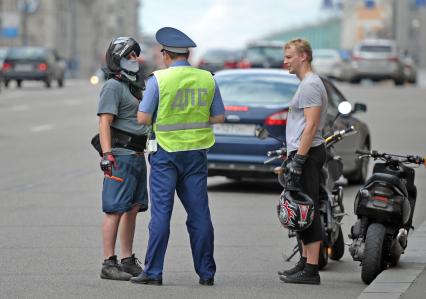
[286,73,328,153]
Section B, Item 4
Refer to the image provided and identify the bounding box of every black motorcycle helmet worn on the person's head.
[105,37,141,73]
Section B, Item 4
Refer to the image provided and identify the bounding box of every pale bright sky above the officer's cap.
[140,0,324,58]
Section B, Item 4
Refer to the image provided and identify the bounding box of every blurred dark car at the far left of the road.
[3,47,66,87]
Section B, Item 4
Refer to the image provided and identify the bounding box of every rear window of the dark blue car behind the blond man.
[215,73,298,106]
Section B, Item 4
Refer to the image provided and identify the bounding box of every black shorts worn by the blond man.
[292,144,326,244]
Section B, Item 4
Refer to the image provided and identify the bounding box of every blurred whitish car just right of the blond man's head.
[312,49,351,81]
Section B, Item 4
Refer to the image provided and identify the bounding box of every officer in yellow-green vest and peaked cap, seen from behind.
[131,27,225,285]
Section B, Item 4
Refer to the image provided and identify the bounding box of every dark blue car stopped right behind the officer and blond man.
[207,69,370,183]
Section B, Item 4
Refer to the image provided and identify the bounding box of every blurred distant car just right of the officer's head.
[198,49,242,72]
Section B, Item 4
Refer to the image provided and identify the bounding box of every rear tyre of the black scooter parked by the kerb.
[361,223,386,284]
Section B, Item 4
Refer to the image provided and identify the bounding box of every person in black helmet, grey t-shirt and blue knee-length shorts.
[98,37,150,280]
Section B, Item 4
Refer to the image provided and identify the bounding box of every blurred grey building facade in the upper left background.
[0,0,139,77]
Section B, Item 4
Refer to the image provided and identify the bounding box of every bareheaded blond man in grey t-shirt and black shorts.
[278,39,328,284]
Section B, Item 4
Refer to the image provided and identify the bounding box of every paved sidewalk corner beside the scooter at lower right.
[358,221,426,299]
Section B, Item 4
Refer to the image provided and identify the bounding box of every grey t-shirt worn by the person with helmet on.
[98,79,150,135]
